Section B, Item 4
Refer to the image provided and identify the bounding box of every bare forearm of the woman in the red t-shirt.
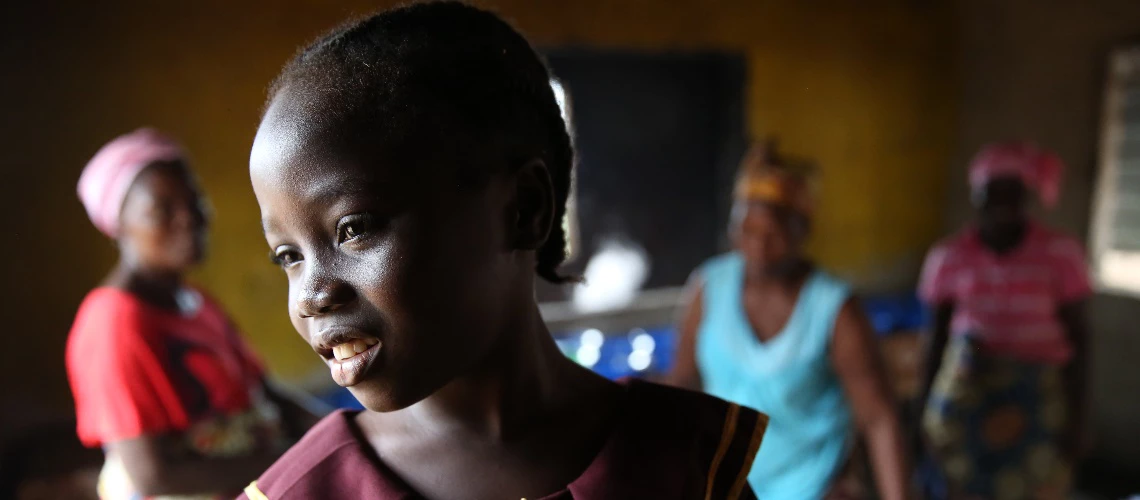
[107,434,284,497]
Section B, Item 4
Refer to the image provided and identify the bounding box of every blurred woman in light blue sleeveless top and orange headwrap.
[671,141,907,500]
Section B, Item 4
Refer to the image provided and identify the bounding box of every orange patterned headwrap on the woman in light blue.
[734,140,813,215]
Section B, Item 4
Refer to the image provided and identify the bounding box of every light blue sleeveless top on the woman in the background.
[697,254,852,500]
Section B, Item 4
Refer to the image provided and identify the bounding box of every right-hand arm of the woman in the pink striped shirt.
[1058,301,1089,461]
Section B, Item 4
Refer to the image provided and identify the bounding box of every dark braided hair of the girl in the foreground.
[267,1,575,284]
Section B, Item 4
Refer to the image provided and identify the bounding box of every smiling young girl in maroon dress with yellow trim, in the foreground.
[246,2,766,500]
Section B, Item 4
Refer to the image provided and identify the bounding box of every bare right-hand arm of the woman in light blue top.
[831,300,910,500]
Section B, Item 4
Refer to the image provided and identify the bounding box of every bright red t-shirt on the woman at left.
[67,287,263,446]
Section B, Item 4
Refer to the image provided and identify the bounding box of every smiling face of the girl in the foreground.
[250,89,522,411]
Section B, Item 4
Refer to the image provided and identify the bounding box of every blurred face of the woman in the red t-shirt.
[119,162,206,273]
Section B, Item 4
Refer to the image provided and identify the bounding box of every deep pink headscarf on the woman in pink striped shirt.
[970,142,1065,208]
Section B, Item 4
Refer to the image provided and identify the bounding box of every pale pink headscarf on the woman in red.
[78,128,186,238]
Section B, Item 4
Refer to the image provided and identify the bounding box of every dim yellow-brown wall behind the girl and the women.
[0,0,954,408]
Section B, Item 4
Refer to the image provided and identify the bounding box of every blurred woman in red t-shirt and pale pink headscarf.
[66,129,316,500]
